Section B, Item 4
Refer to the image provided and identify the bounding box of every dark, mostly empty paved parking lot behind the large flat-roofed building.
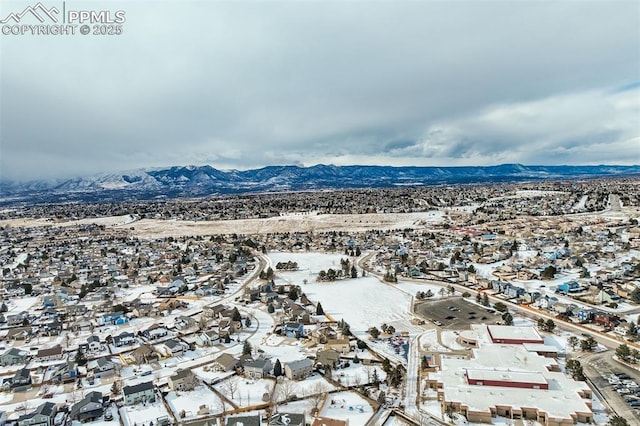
[416,296,501,330]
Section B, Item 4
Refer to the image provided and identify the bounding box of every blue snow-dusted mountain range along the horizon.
[0,164,640,205]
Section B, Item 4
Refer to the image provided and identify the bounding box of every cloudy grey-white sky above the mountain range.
[0,0,640,180]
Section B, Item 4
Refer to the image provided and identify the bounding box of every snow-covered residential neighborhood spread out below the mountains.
[0,179,640,426]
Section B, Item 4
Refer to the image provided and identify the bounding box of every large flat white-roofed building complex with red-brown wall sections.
[426,325,593,426]
